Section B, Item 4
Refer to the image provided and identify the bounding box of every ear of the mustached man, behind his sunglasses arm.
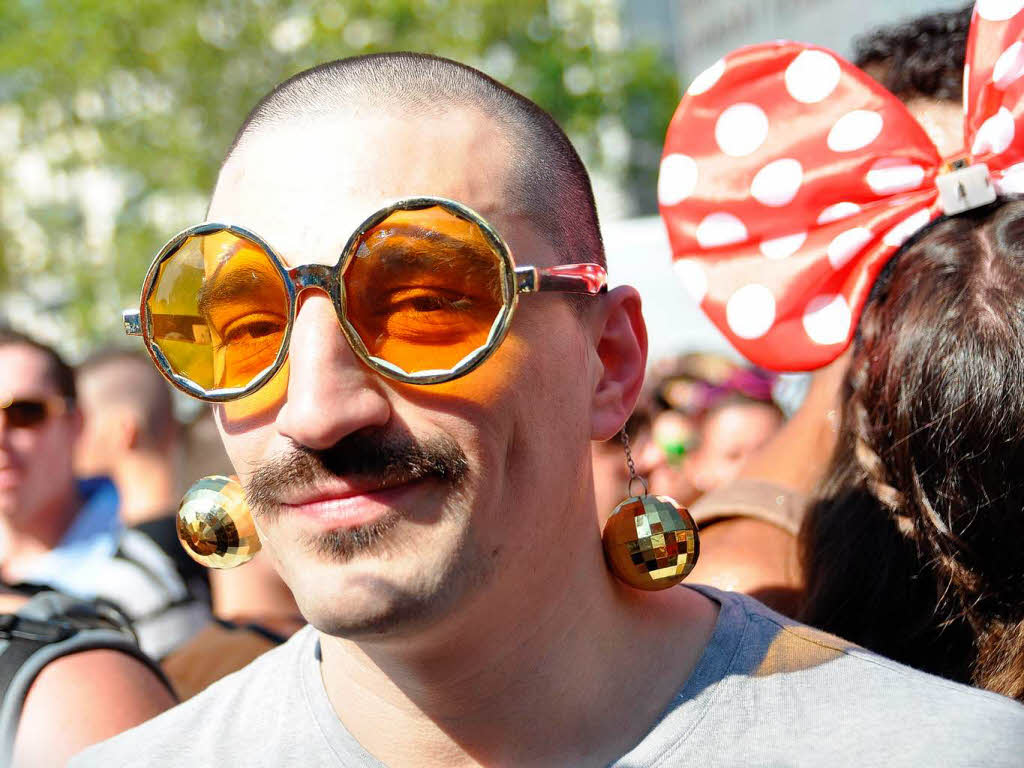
[590,286,647,440]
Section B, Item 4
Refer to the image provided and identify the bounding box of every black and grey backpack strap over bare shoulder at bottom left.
[0,592,177,765]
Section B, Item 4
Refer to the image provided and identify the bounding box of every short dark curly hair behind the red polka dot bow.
[854,4,974,101]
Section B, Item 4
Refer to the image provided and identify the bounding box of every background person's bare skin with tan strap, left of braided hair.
[690,353,849,615]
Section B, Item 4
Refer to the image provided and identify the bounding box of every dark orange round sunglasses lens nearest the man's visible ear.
[343,206,508,375]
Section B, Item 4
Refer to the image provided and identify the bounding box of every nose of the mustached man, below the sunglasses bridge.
[275,291,391,451]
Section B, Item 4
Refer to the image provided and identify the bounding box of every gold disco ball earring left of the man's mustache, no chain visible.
[177,475,260,568]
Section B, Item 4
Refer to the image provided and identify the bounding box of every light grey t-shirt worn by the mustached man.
[71,587,1024,768]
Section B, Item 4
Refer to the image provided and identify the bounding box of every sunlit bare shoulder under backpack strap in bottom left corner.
[14,649,175,768]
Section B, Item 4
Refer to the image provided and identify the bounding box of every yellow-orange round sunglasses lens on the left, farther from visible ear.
[146,231,289,391]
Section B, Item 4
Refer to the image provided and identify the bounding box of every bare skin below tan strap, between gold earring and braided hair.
[689,517,803,615]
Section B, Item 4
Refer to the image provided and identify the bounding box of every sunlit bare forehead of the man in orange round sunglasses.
[208,108,509,264]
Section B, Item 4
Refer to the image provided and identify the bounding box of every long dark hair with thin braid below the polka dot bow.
[803,201,1024,698]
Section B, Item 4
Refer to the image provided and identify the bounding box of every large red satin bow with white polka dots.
[657,0,1024,371]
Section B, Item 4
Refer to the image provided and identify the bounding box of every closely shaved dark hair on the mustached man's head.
[224,53,604,274]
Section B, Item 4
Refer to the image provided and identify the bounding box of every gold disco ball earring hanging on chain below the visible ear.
[601,429,700,591]
